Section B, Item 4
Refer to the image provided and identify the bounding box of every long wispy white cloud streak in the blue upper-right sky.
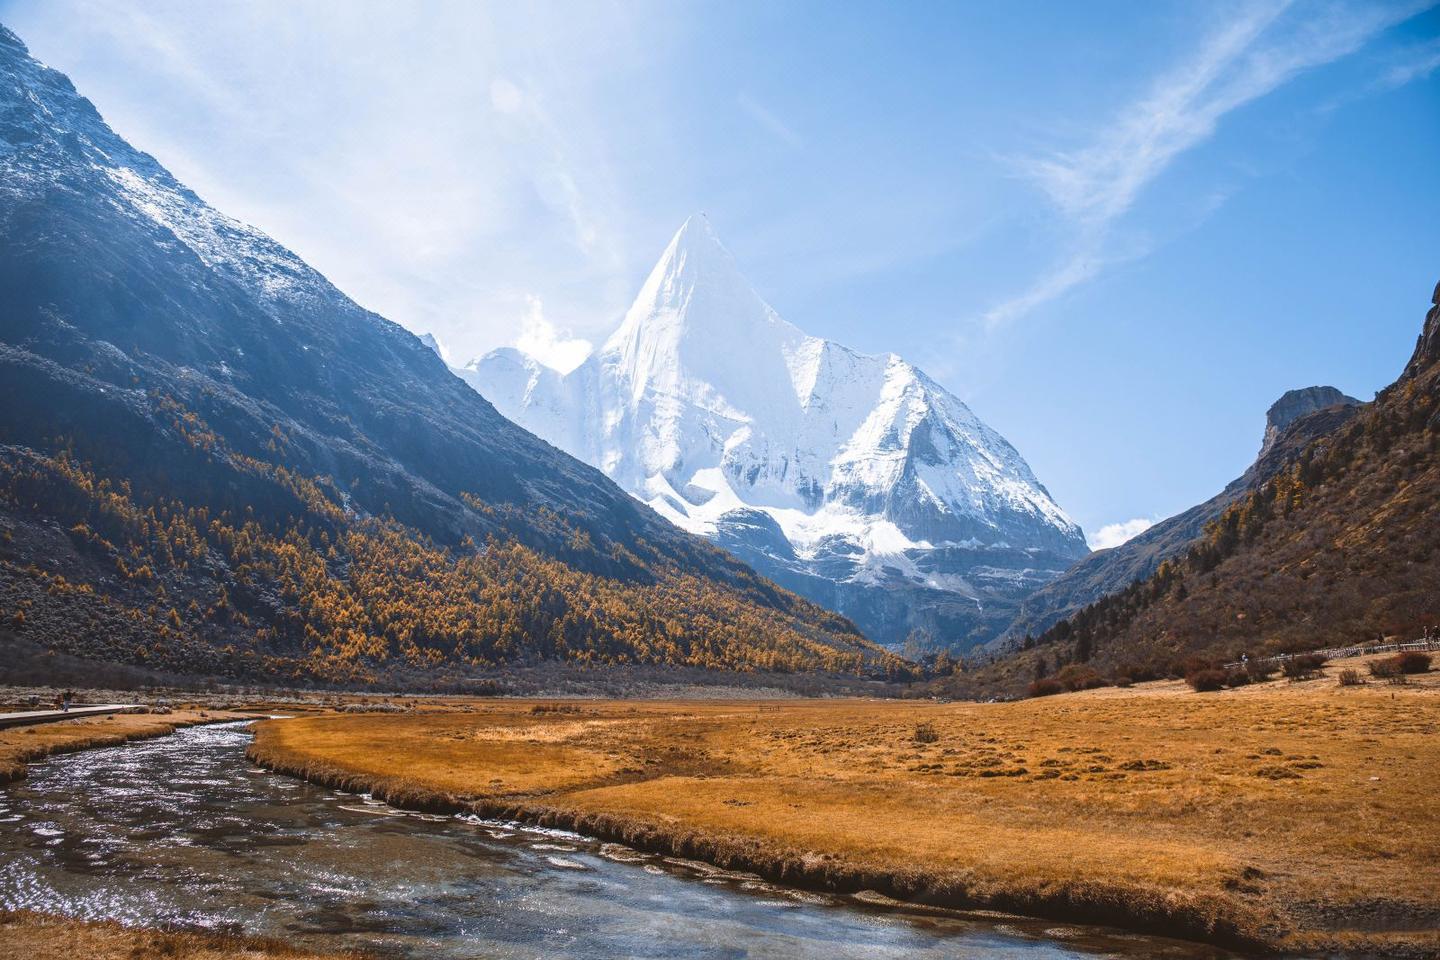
[981,0,1436,331]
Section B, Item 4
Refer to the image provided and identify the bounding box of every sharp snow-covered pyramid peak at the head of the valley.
[443,216,1087,649]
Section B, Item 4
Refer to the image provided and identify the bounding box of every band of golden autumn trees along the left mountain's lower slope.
[0,412,899,684]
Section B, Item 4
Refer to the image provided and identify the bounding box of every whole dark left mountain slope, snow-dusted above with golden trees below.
[0,27,880,679]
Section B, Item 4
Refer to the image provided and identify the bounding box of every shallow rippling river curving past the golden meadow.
[0,724,1230,960]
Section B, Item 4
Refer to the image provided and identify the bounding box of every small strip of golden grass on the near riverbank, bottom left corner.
[0,911,355,960]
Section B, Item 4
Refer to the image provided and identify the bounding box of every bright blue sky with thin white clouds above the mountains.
[0,0,1440,540]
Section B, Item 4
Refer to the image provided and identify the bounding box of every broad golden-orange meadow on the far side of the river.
[251,664,1440,956]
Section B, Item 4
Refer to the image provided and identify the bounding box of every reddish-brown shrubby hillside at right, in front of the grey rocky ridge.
[976,288,1440,687]
